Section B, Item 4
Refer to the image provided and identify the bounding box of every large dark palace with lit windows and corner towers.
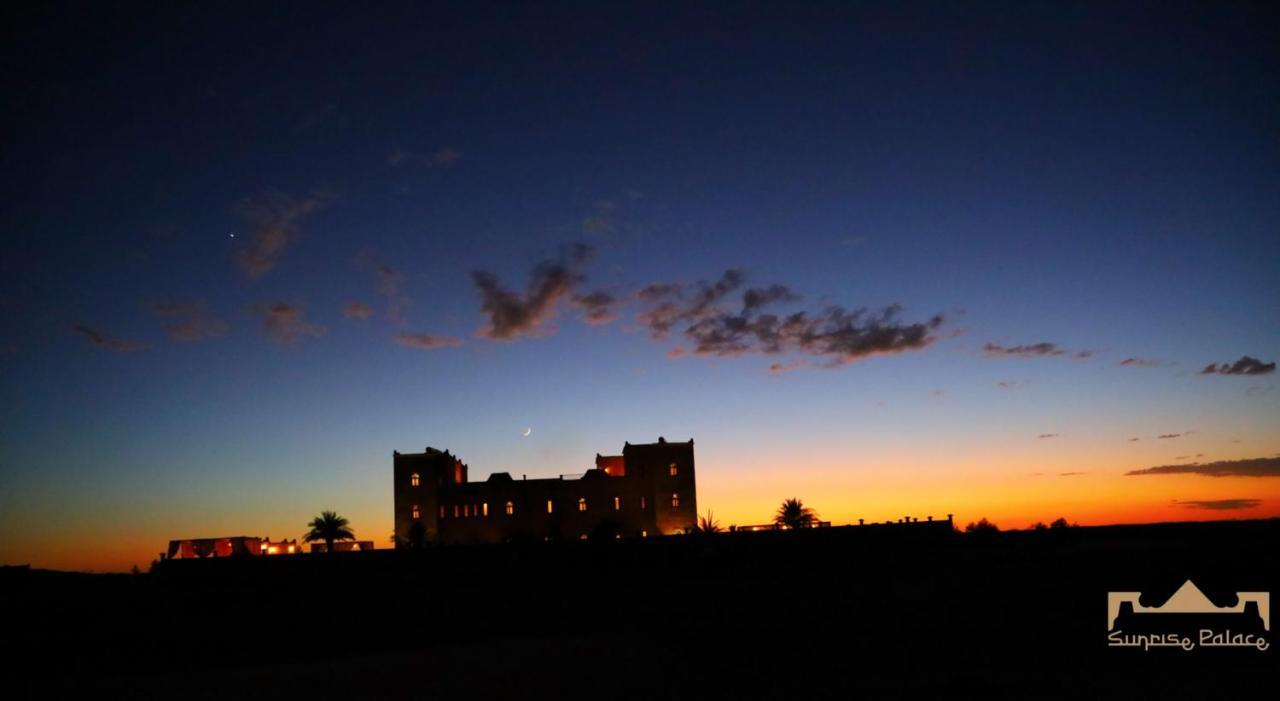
[393,437,698,547]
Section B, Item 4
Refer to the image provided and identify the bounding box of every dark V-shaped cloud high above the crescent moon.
[471,243,594,340]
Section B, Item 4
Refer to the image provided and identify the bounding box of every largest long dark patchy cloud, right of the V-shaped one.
[636,269,943,367]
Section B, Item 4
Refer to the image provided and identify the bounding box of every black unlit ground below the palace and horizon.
[0,521,1280,700]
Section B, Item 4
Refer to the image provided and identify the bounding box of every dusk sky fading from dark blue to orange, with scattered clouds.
[0,3,1280,571]
